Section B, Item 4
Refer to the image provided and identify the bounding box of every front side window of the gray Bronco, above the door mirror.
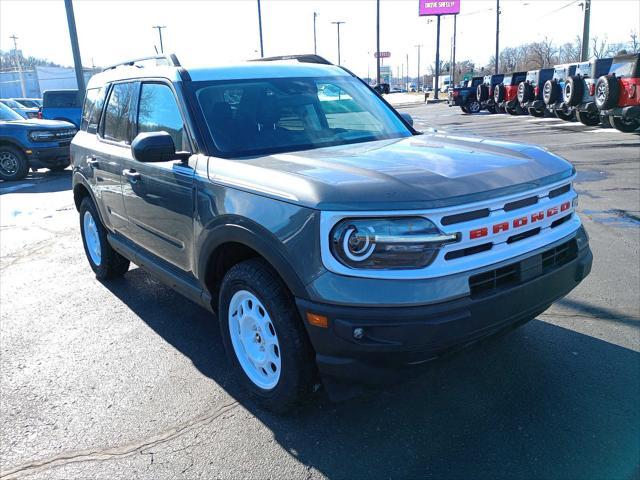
[138,83,189,150]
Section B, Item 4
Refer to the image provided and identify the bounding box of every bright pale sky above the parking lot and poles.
[0,0,640,76]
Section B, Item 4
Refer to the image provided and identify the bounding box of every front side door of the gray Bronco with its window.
[122,81,195,272]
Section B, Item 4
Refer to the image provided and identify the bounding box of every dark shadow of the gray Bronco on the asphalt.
[105,269,640,479]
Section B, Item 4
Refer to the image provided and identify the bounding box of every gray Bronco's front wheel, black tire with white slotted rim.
[219,259,317,412]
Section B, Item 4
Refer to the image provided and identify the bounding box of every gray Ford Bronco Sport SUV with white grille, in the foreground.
[71,55,592,411]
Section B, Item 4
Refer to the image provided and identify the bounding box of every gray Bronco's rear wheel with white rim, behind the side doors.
[80,197,129,280]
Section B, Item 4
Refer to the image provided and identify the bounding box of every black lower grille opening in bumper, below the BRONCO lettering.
[469,239,578,296]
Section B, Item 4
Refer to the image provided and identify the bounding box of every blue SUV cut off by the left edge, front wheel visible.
[0,104,77,180]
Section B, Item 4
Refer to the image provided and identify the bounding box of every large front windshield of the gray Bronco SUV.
[194,76,411,157]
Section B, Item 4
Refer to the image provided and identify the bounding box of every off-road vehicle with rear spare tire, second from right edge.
[563,58,613,126]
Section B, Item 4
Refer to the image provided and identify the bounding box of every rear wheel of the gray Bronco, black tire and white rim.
[80,197,130,280]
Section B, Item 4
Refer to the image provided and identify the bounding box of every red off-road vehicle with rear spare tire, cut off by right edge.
[595,53,640,132]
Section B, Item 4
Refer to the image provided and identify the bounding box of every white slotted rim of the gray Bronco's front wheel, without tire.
[227,290,282,390]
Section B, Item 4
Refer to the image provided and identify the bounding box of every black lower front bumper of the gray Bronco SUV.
[296,227,593,394]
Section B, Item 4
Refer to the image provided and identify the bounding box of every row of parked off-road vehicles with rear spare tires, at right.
[449,53,640,132]
